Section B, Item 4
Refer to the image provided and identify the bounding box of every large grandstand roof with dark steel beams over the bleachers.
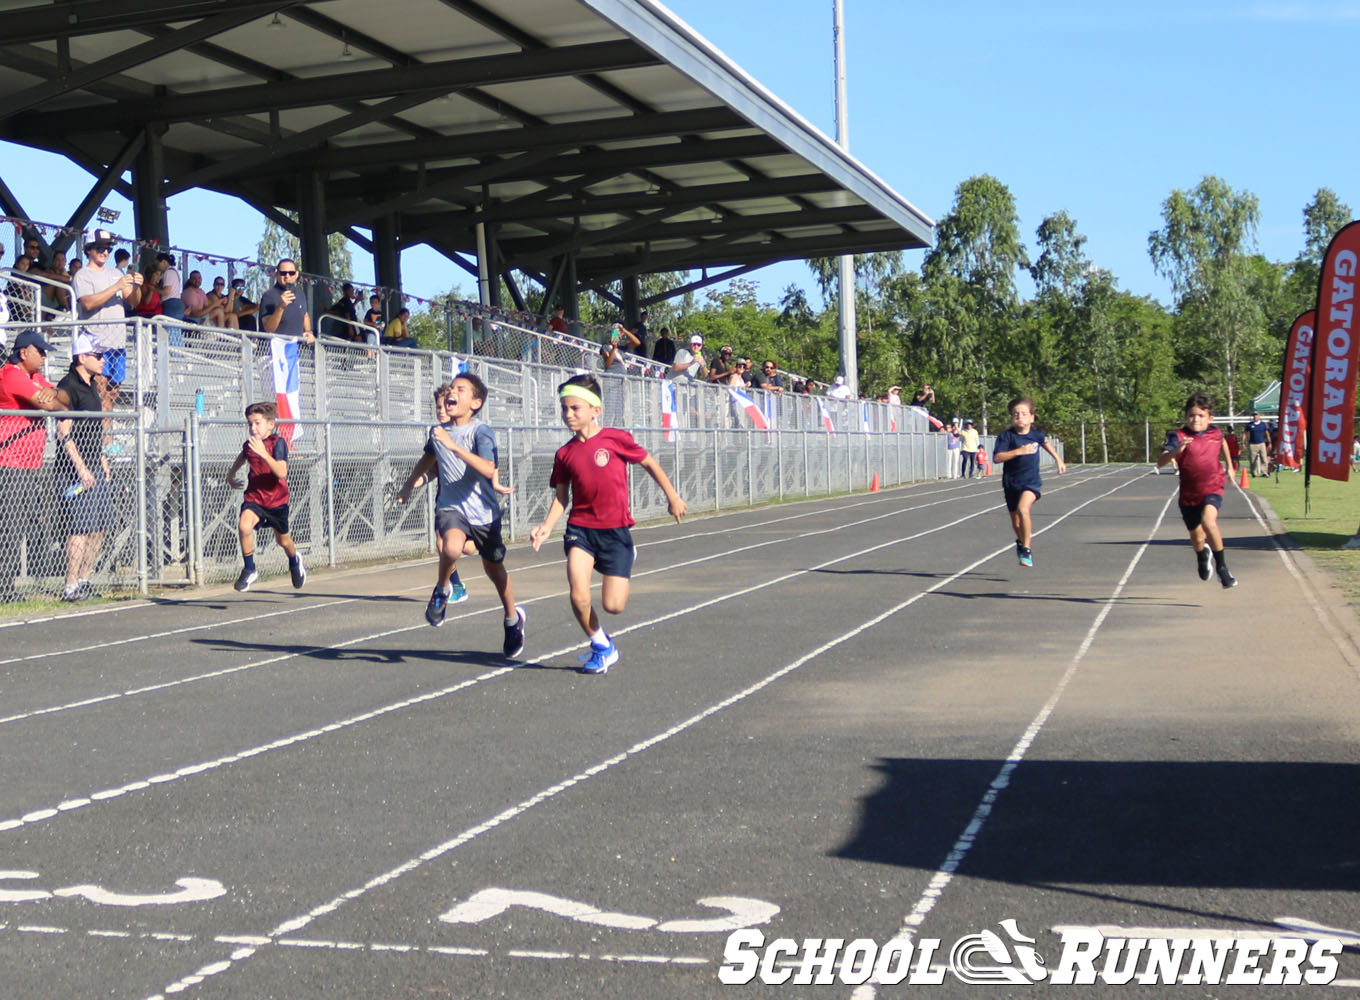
[0,0,933,283]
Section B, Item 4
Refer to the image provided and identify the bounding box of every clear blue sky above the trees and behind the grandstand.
[0,0,1360,308]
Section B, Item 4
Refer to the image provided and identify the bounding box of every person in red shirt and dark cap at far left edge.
[0,329,71,604]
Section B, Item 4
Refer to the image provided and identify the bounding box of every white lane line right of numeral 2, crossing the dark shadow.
[850,494,1175,1000]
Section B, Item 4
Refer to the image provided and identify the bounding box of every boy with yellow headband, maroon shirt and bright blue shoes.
[529,376,685,673]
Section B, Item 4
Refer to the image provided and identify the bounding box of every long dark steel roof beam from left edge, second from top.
[11,39,658,139]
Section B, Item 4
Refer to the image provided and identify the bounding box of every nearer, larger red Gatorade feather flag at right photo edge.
[1306,222,1360,483]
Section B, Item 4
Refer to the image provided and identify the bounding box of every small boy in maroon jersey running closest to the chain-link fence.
[227,403,307,593]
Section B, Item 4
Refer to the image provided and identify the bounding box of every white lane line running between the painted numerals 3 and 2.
[147,476,1147,1000]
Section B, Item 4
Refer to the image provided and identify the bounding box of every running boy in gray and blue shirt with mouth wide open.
[397,373,525,657]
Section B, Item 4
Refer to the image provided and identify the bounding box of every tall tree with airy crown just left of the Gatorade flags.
[1148,177,1265,414]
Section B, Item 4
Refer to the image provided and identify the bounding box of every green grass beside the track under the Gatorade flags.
[1251,472,1360,611]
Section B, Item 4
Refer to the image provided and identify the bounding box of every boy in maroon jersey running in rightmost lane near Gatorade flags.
[1157,392,1238,588]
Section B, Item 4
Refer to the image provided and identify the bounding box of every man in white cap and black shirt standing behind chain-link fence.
[56,334,114,601]
